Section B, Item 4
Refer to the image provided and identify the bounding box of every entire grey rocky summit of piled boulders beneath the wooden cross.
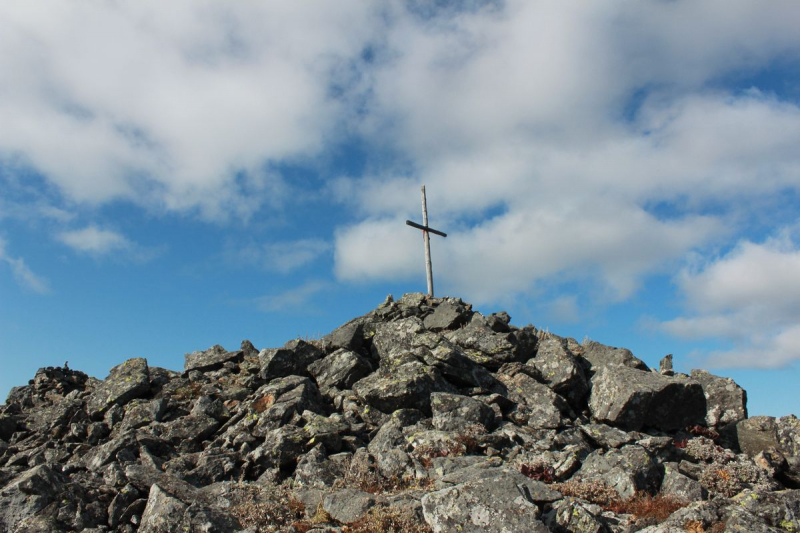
[0,294,800,533]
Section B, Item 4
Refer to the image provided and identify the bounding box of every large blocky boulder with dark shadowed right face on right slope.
[589,366,706,431]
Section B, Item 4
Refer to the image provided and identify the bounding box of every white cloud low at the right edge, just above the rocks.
[661,230,800,367]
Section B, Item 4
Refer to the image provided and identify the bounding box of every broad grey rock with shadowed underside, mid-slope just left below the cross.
[353,362,457,413]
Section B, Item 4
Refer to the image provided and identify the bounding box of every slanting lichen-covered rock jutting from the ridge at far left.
[86,357,150,418]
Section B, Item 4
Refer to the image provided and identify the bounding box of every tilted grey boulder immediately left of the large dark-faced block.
[527,336,589,408]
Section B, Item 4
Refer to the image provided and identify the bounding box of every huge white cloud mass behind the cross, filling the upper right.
[332,1,800,302]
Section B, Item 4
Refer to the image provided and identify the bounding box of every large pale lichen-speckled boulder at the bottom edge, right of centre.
[422,469,561,533]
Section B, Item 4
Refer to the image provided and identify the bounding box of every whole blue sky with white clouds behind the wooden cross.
[0,0,800,416]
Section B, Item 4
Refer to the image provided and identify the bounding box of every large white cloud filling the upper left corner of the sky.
[0,0,380,218]
